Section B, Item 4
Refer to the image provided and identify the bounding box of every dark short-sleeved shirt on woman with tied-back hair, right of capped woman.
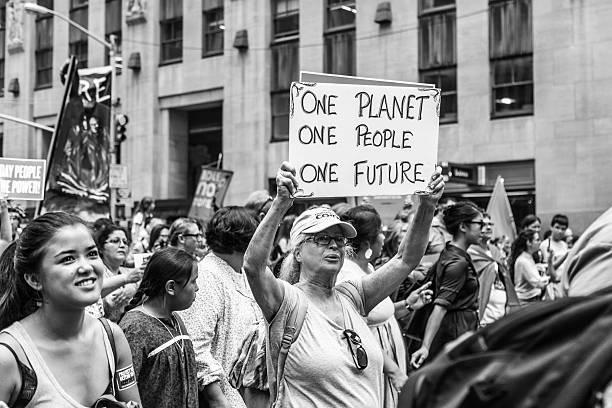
[434,242,479,311]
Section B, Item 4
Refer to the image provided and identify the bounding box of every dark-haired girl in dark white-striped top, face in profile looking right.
[119,248,198,408]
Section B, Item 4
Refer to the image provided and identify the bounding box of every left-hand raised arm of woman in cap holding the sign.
[243,162,298,321]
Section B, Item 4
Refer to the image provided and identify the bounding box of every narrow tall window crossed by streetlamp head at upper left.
[35,0,53,89]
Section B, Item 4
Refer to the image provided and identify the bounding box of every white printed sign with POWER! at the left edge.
[0,158,47,200]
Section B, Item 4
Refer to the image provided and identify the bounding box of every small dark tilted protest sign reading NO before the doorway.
[189,166,234,220]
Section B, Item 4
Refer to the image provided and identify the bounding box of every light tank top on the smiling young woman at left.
[2,322,115,408]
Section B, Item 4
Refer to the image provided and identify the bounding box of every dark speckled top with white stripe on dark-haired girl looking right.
[119,309,198,408]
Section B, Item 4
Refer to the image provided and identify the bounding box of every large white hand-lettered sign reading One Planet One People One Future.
[289,82,440,197]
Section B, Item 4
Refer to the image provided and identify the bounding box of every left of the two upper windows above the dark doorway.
[159,0,183,64]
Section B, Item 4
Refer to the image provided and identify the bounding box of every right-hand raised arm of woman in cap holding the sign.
[363,171,444,313]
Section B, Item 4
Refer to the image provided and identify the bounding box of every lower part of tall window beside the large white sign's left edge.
[270,40,299,141]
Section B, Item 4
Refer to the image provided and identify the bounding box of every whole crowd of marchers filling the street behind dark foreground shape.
[0,163,604,408]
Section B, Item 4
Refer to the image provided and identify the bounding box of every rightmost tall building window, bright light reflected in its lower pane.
[489,0,533,118]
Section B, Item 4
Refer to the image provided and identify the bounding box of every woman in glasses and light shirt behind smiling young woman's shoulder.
[96,224,143,322]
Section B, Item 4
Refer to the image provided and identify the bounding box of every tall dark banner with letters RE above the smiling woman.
[41,58,112,221]
